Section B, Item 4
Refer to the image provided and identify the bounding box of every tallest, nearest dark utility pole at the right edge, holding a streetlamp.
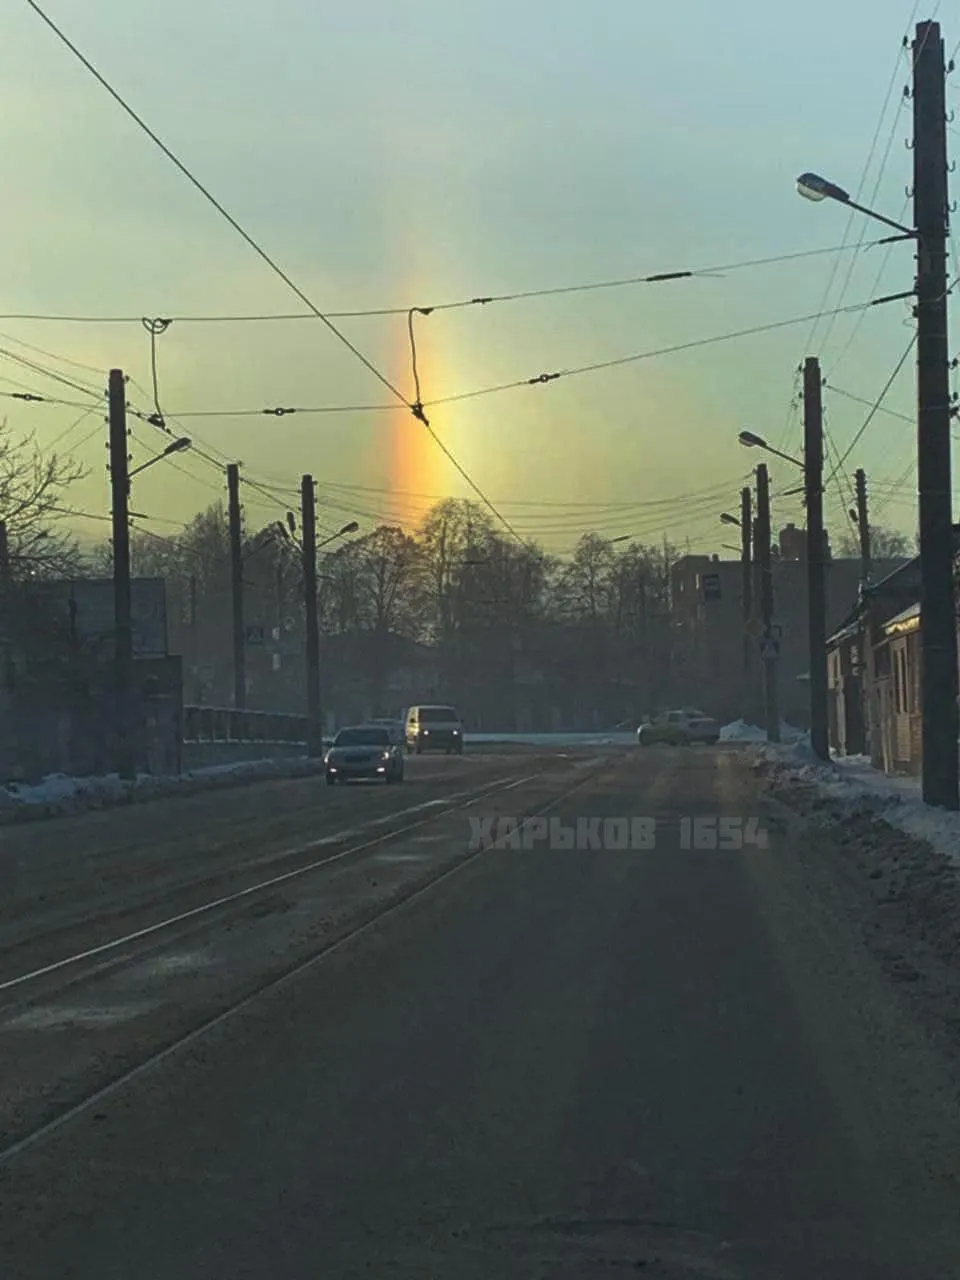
[913,22,960,809]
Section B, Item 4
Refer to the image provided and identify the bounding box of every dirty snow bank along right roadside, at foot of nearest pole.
[756,744,960,867]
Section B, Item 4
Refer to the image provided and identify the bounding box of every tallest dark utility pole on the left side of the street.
[108,369,137,781]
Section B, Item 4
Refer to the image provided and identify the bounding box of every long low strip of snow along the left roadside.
[0,756,321,823]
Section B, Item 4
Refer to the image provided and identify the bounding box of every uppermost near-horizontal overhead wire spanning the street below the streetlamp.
[0,237,887,327]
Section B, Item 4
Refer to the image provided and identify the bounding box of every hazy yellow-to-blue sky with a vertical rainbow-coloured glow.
[0,0,960,550]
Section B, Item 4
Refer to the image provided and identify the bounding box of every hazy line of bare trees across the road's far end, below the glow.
[120,499,680,728]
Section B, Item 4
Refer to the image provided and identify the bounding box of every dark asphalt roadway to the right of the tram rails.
[0,749,960,1280]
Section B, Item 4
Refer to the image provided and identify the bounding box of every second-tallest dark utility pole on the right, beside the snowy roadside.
[804,356,829,760]
